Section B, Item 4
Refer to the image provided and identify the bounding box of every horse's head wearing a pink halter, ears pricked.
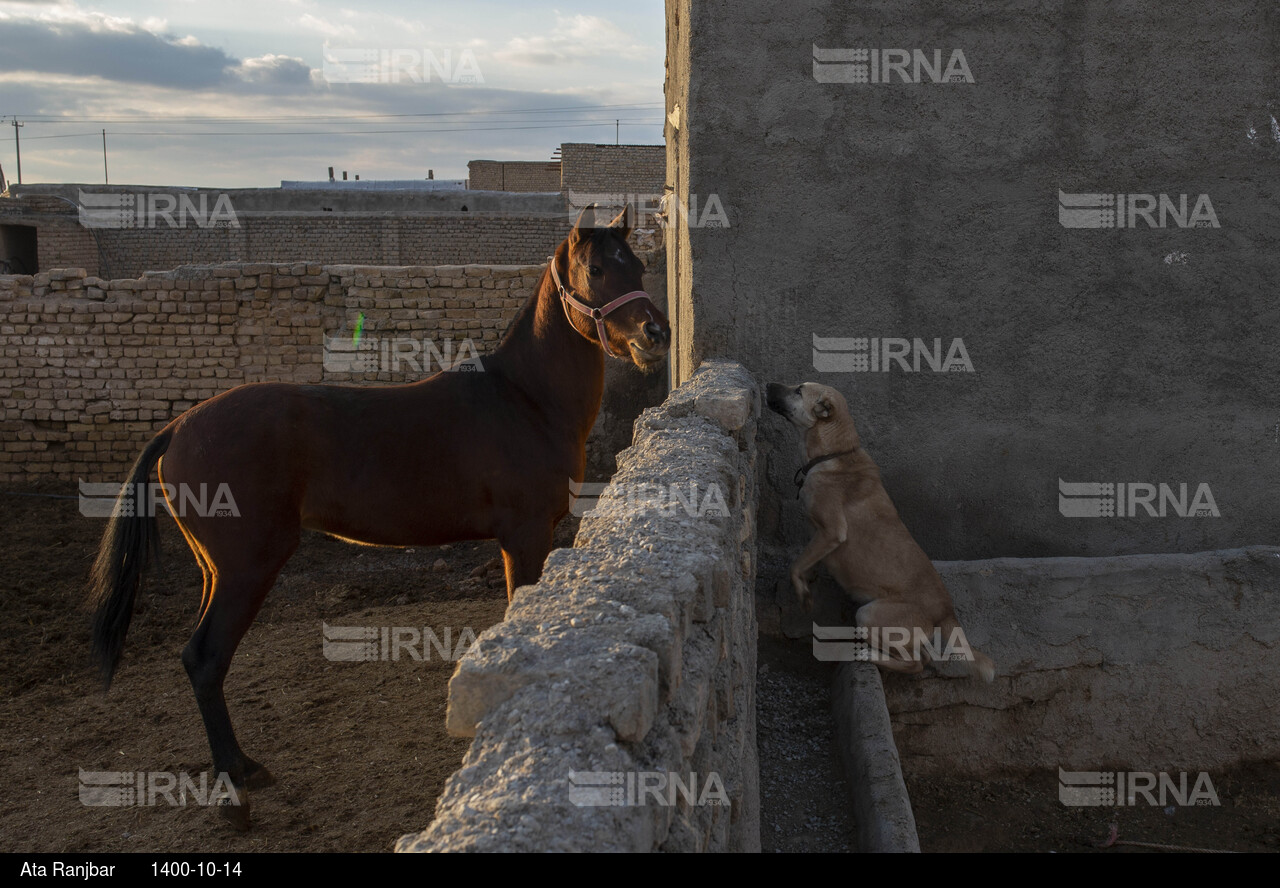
[552,207,671,370]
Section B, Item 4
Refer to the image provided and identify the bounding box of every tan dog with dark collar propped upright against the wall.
[768,383,996,682]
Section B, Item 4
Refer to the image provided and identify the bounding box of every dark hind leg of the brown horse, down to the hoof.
[182,540,297,829]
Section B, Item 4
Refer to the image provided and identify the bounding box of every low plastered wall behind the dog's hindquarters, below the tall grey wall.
[783,546,1280,778]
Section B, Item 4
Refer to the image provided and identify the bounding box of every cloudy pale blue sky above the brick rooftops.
[0,0,664,188]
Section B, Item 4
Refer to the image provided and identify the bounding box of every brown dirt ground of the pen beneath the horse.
[0,491,576,852]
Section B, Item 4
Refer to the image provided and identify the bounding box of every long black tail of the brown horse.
[90,430,173,690]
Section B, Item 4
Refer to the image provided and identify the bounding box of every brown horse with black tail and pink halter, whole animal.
[92,204,671,829]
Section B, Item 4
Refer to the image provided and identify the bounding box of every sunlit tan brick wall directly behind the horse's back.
[0,252,666,485]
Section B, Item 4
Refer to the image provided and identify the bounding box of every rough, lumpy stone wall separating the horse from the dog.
[397,362,760,851]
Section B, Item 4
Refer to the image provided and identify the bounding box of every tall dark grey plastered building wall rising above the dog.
[667,0,1280,567]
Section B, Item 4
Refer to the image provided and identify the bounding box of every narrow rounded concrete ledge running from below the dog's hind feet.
[831,663,920,853]
